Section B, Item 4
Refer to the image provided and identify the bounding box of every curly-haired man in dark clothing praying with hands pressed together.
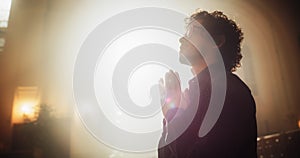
[158,11,257,158]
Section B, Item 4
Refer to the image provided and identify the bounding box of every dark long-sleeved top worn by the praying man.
[158,68,257,158]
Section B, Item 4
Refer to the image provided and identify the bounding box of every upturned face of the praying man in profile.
[179,20,211,65]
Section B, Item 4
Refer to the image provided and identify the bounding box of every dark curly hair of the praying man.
[187,10,244,72]
